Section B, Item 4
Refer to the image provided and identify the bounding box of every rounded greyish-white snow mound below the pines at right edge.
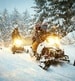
[61,31,75,44]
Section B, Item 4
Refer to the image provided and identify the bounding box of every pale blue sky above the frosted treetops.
[0,0,34,14]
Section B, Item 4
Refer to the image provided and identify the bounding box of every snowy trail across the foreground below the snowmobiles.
[0,48,75,81]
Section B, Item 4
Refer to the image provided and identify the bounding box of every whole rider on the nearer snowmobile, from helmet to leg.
[32,23,47,55]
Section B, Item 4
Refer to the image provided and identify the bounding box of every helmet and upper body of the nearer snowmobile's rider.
[33,23,47,42]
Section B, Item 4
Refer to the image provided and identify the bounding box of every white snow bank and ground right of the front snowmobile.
[61,31,75,64]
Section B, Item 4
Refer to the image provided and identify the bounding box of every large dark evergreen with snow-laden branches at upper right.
[34,0,75,36]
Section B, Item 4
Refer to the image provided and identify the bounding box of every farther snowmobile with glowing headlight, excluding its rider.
[12,39,24,54]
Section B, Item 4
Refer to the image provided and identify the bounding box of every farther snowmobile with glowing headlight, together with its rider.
[11,28,24,54]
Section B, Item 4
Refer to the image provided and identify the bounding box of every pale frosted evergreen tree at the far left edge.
[0,9,9,41]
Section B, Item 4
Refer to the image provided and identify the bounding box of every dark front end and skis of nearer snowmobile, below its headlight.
[38,47,70,70]
